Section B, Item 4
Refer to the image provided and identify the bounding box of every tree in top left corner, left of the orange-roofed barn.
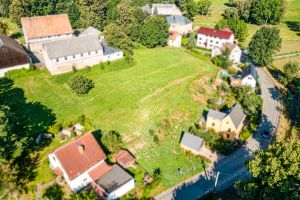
[9,0,30,25]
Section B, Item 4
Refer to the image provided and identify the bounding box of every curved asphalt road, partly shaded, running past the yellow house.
[155,68,280,200]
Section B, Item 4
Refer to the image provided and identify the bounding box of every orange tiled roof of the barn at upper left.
[21,14,73,39]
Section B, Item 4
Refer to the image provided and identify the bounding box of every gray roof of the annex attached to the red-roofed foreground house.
[96,164,133,193]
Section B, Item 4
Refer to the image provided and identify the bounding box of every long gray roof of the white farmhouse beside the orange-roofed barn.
[43,34,102,59]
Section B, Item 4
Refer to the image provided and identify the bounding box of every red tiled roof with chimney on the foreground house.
[53,133,106,180]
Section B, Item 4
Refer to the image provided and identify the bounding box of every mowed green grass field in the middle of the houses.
[11,48,218,195]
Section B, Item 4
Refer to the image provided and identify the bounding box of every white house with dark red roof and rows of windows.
[196,27,234,49]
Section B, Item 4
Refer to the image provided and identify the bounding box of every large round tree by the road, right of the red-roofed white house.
[249,27,281,66]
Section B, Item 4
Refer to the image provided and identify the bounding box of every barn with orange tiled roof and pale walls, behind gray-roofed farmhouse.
[21,14,73,51]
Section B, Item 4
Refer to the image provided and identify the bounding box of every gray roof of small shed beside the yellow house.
[180,132,204,152]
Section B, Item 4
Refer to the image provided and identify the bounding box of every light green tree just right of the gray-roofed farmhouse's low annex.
[103,23,133,59]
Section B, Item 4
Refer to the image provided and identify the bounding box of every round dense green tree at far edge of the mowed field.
[141,15,169,48]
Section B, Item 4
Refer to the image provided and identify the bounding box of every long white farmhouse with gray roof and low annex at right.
[42,34,123,75]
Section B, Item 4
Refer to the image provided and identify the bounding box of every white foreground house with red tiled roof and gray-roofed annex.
[48,133,135,199]
